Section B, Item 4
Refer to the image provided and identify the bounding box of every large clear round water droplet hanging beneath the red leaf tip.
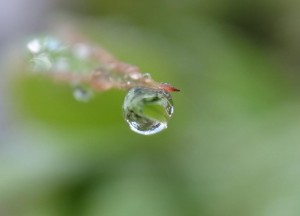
[123,87,174,135]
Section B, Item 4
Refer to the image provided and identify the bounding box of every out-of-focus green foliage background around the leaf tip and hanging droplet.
[0,0,300,216]
